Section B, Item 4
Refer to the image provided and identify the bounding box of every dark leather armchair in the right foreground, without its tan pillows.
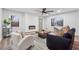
[46,28,75,50]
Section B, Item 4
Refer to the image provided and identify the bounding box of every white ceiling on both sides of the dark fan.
[4,8,79,15]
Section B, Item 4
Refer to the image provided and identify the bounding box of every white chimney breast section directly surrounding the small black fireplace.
[25,14,39,32]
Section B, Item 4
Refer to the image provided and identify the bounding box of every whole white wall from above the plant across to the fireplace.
[3,9,38,32]
